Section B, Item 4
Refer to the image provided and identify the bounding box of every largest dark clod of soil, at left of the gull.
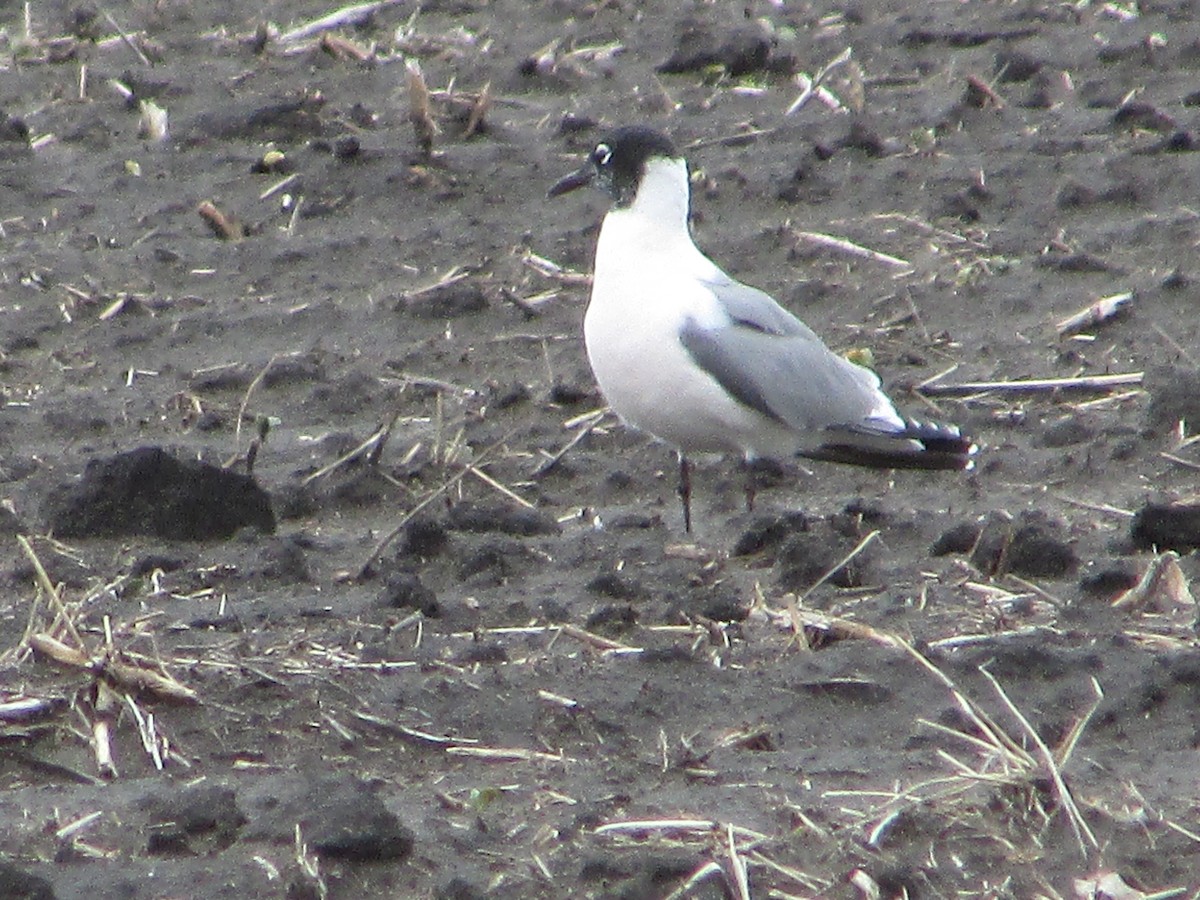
[46,446,275,540]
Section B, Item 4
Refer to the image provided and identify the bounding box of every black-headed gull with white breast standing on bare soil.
[550,125,977,533]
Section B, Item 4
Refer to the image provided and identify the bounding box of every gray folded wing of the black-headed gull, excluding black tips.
[679,278,889,431]
